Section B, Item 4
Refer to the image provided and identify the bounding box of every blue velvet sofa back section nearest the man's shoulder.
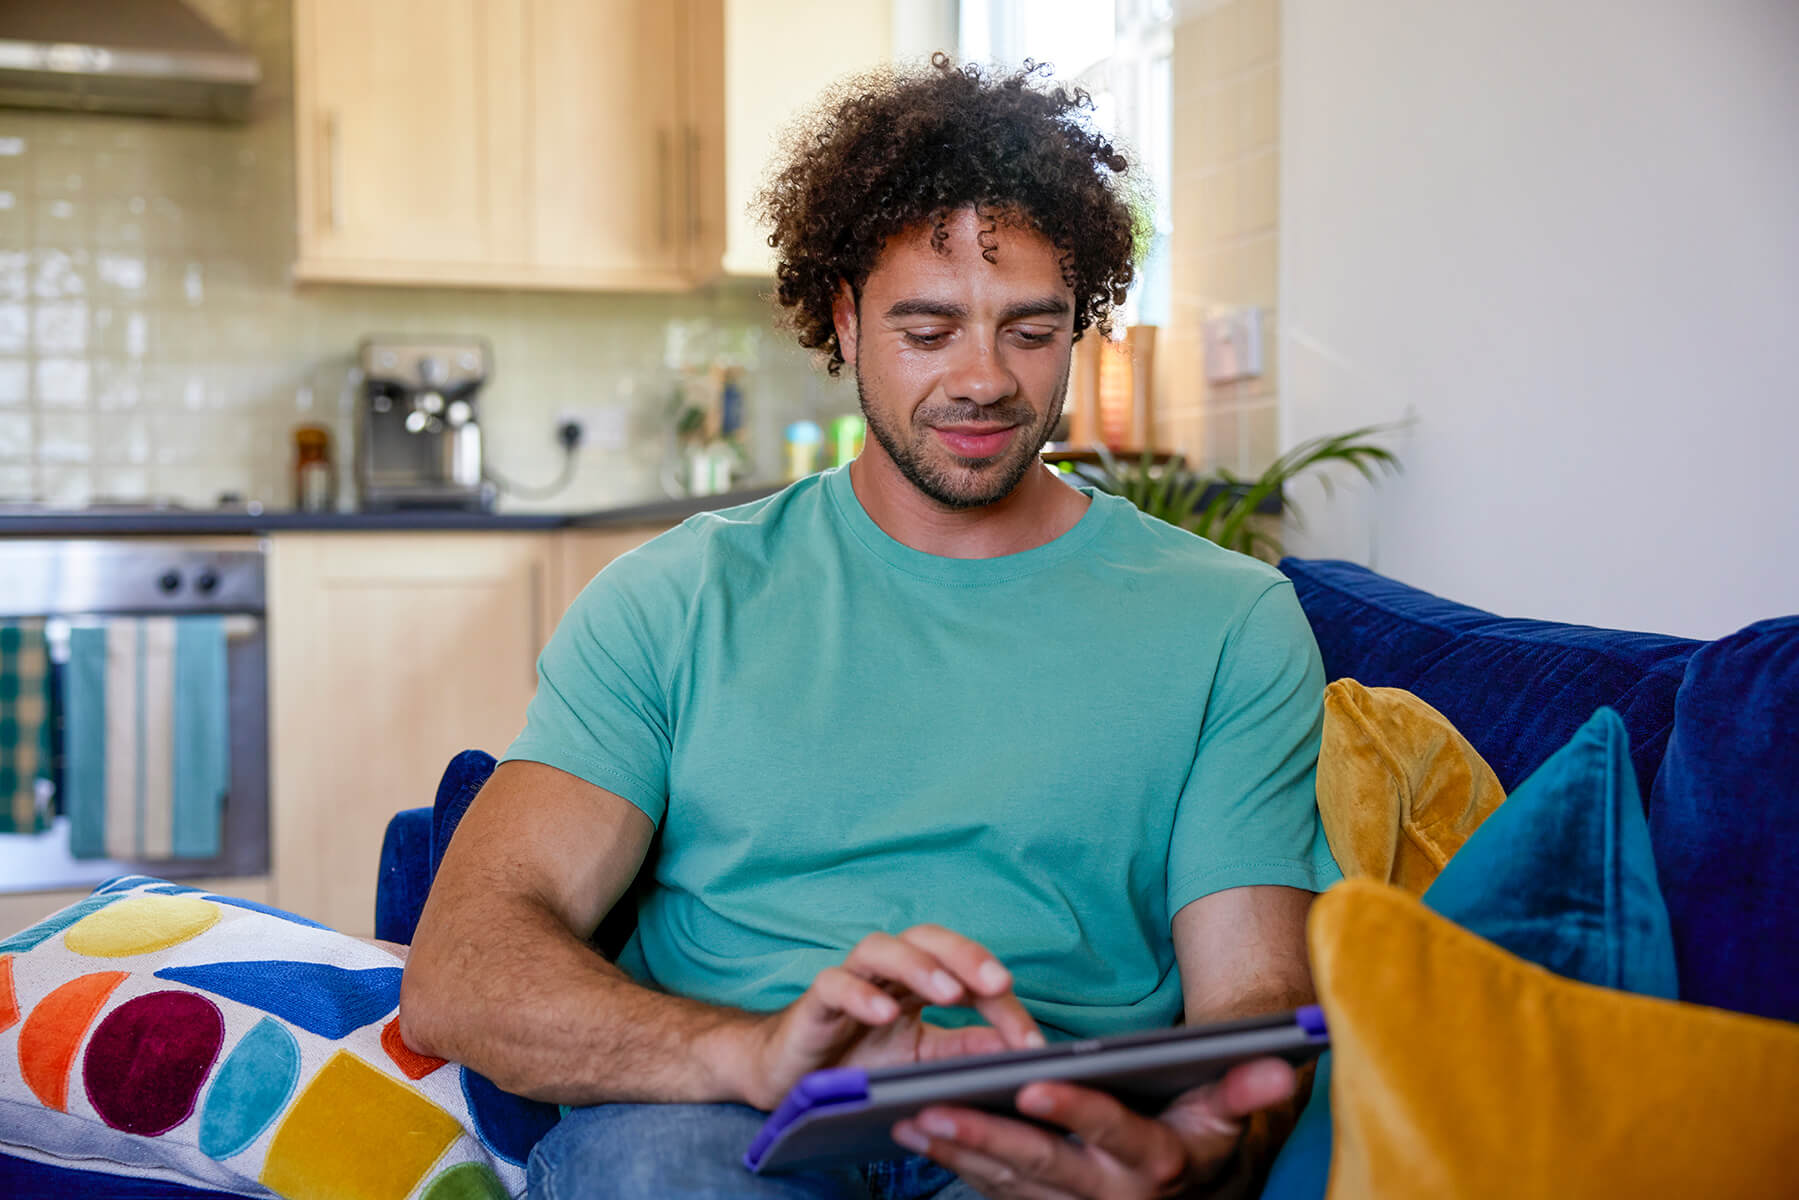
[1281,558,1704,797]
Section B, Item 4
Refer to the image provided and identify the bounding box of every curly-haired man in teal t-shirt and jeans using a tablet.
[401,59,1337,1196]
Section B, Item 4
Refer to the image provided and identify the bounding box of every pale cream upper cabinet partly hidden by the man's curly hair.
[725,0,892,275]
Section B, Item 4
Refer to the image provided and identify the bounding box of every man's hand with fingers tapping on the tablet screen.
[739,925,1043,1108]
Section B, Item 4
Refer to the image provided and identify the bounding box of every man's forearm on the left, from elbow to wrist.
[399,900,759,1105]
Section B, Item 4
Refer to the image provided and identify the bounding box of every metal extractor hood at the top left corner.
[0,0,263,121]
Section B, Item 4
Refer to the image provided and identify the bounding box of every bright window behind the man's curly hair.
[959,0,1175,326]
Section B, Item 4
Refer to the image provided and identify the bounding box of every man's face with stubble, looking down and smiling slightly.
[835,209,1074,509]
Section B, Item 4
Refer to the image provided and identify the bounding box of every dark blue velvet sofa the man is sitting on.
[376,558,1799,1020]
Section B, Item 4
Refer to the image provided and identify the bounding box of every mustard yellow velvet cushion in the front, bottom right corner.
[1308,880,1799,1200]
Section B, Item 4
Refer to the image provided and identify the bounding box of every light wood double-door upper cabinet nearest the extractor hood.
[293,0,725,290]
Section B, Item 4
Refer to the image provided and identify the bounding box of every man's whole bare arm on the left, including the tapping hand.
[399,763,1042,1108]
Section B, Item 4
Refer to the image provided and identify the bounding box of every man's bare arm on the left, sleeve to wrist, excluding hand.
[399,763,756,1105]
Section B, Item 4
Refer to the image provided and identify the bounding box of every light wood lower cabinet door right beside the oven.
[268,533,559,934]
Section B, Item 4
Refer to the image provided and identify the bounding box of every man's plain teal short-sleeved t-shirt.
[506,470,1338,1036]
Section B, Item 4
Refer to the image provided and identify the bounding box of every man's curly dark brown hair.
[756,54,1137,376]
